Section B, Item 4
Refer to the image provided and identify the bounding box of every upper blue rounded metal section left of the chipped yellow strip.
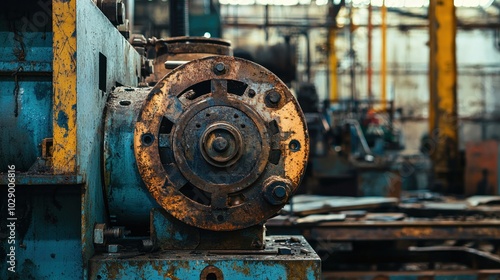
[0,30,52,172]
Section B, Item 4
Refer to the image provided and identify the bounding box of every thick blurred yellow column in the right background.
[429,0,458,192]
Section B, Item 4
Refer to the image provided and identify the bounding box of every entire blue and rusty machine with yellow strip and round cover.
[0,0,320,280]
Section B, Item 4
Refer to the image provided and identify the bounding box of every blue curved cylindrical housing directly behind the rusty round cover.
[103,87,160,229]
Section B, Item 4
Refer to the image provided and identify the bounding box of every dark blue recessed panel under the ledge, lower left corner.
[0,186,82,280]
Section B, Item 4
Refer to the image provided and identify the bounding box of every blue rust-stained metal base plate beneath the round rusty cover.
[89,236,321,280]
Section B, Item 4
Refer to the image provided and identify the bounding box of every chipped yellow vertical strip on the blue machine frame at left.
[52,0,77,174]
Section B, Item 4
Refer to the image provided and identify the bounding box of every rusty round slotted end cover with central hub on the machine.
[134,56,309,231]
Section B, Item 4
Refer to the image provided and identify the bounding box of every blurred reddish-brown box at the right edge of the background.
[465,140,500,195]
